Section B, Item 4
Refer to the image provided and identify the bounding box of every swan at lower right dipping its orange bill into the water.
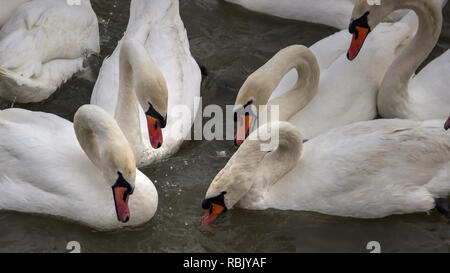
[202,119,450,225]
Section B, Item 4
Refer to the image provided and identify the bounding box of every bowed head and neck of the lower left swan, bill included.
[73,105,136,223]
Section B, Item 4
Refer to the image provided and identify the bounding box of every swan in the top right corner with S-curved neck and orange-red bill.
[348,0,450,120]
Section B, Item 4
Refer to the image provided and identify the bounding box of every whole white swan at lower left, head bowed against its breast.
[0,105,158,230]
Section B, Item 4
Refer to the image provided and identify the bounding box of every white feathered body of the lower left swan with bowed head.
[0,106,158,230]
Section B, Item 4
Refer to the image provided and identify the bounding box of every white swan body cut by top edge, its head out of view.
[225,0,414,29]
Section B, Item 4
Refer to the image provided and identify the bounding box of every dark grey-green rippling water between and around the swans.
[0,0,450,252]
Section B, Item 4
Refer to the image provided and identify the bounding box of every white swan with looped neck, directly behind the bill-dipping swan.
[234,22,412,145]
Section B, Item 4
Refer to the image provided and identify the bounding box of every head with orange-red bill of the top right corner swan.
[347,0,395,61]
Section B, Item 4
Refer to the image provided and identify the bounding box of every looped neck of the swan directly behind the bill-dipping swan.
[237,45,320,120]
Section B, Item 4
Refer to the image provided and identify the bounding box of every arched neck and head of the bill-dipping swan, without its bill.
[210,122,303,208]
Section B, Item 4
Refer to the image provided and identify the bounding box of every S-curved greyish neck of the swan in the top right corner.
[380,0,442,113]
